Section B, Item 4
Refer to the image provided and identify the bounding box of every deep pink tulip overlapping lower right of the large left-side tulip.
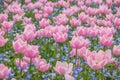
[25,45,39,58]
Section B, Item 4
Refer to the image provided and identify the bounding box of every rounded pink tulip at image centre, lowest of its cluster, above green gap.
[53,32,68,43]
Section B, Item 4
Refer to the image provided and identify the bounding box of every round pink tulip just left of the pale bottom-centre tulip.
[36,59,50,72]
